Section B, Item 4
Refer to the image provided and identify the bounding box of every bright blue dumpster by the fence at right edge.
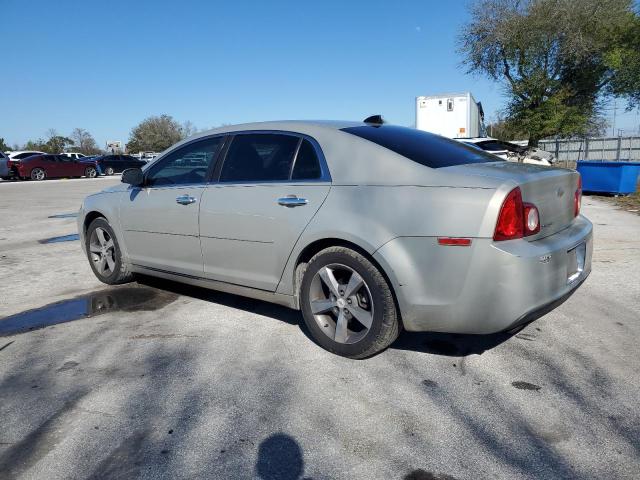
[577,160,640,194]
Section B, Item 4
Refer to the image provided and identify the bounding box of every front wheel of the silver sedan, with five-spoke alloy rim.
[85,218,133,285]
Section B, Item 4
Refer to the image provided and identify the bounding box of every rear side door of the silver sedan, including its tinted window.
[200,132,331,291]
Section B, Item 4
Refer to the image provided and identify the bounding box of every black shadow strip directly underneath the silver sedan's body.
[136,275,517,357]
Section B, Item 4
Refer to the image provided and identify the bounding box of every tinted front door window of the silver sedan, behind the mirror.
[145,137,224,186]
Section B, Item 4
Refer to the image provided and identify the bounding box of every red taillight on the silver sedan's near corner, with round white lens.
[493,187,540,241]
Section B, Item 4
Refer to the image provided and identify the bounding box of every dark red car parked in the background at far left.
[11,155,98,180]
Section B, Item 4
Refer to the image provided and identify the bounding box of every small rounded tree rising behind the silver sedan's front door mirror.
[127,115,183,152]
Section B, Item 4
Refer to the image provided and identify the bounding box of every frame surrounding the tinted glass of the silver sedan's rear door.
[215,130,331,186]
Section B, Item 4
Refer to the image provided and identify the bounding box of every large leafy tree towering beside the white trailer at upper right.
[458,0,640,145]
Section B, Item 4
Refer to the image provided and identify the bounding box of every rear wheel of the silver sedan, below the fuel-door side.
[300,247,400,358]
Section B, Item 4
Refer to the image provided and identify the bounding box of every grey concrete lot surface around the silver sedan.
[0,178,640,480]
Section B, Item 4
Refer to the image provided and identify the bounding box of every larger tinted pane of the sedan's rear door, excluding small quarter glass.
[220,133,300,182]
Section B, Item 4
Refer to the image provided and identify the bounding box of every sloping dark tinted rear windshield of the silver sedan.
[342,125,503,168]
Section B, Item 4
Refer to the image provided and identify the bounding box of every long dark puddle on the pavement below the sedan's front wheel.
[0,287,179,337]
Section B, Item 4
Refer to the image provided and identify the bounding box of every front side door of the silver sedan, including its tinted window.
[120,137,223,276]
